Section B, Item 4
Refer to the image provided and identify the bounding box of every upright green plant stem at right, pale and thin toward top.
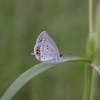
[83,0,95,100]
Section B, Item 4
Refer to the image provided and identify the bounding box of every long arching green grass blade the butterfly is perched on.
[1,57,90,100]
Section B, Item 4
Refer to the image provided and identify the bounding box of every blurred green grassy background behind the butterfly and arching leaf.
[0,0,100,100]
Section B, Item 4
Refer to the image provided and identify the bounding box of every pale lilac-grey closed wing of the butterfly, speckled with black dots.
[34,31,60,61]
